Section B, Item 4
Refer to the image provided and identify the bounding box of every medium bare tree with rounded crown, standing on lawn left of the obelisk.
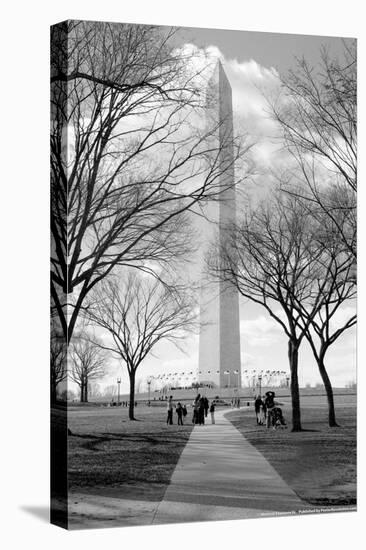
[85,271,197,420]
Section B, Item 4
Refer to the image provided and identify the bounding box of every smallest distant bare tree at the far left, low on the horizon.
[70,335,106,403]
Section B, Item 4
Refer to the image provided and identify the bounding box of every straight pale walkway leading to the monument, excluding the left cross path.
[152,411,309,523]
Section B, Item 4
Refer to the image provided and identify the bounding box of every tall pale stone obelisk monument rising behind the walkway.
[198,61,241,387]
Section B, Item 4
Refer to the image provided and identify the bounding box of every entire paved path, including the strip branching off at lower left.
[69,410,310,529]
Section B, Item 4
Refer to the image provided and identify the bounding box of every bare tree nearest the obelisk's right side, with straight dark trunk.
[208,193,325,431]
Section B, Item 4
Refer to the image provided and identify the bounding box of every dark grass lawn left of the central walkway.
[68,406,193,501]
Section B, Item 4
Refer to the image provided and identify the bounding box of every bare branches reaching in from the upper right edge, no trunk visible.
[271,39,357,258]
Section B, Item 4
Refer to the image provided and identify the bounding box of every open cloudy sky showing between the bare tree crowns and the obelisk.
[83,29,356,392]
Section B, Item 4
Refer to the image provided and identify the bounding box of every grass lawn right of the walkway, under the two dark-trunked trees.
[227,400,356,506]
